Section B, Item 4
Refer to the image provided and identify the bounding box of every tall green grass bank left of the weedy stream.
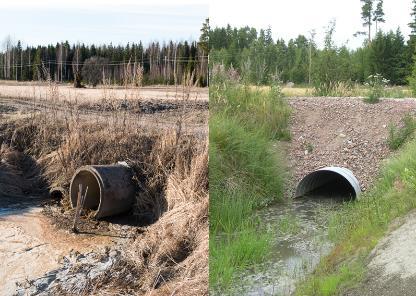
[209,80,290,289]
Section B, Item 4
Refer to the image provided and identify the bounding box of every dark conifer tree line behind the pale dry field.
[0,37,208,87]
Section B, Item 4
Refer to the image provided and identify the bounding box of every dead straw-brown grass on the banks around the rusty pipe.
[0,78,208,295]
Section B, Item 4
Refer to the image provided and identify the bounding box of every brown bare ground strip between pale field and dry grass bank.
[0,96,209,134]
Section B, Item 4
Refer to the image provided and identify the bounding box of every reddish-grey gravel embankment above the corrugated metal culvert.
[288,97,416,190]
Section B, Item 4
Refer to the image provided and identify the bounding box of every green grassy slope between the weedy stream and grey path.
[296,140,416,295]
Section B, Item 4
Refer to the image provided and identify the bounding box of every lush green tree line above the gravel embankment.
[209,0,416,85]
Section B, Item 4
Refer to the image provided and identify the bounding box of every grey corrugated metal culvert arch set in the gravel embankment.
[295,167,361,200]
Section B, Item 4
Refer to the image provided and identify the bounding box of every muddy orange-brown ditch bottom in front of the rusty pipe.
[0,197,133,295]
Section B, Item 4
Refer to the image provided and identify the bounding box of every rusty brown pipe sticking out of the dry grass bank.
[69,164,135,218]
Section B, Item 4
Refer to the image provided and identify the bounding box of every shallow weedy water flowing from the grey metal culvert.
[231,196,342,296]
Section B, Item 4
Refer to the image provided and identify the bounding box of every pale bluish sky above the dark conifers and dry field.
[0,0,208,45]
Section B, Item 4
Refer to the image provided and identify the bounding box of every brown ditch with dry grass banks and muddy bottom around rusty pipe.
[0,96,208,295]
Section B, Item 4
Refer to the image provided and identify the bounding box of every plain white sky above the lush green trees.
[210,0,412,48]
